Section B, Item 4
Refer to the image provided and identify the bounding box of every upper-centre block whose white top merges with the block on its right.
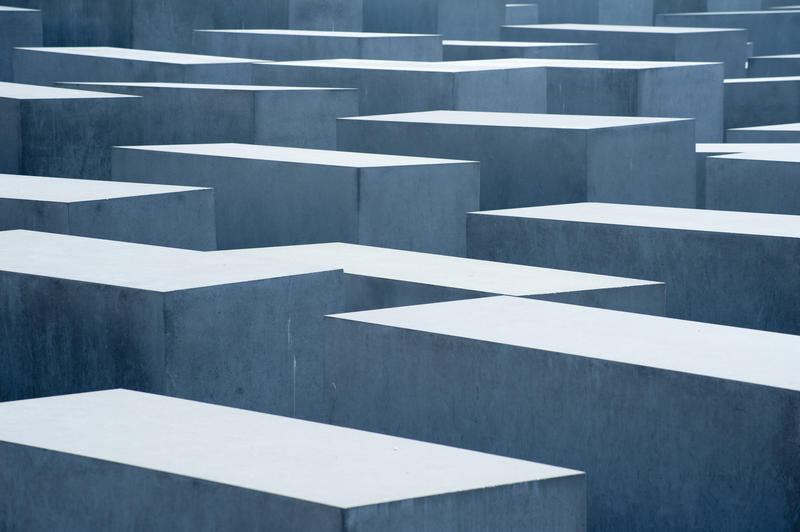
[253,59,547,114]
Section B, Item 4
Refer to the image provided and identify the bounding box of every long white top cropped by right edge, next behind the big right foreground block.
[472,203,800,238]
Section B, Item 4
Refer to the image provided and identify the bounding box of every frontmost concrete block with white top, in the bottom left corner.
[0,390,586,532]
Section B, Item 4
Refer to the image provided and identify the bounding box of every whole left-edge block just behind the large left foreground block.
[0,174,217,251]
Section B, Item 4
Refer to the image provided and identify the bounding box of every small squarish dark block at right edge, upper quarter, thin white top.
[725,76,800,129]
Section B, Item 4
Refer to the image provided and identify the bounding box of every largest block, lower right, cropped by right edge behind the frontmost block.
[325,297,800,532]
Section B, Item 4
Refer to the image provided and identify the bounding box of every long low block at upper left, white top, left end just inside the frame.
[14,46,252,85]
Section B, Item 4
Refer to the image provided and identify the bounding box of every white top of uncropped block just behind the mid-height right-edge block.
[341,111,686,129]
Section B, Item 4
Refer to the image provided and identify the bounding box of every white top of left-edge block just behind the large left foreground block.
[0,174,209,203]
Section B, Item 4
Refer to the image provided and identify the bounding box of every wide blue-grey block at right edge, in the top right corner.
[656,10,800,55]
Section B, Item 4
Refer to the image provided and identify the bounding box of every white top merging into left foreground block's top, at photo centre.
[216,243,659,296]
